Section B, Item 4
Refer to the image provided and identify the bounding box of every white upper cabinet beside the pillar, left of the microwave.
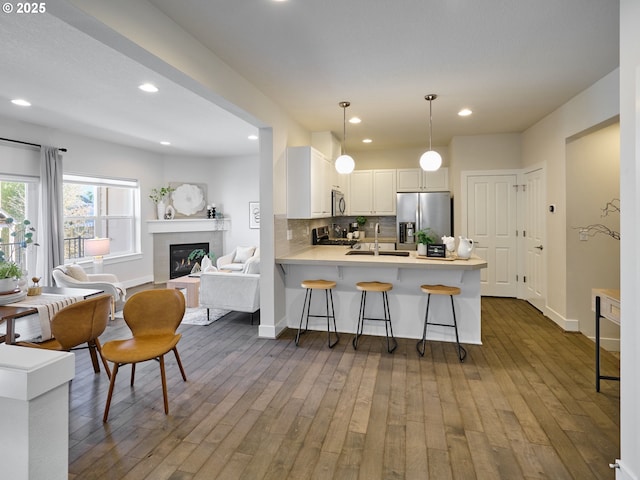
[287,147,334,218]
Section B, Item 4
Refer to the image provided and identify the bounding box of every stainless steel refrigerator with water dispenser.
[396,192,453,250]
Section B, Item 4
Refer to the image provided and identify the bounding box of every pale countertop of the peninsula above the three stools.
[276,246,487,270]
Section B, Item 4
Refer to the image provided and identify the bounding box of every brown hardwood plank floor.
[69,292,620,480]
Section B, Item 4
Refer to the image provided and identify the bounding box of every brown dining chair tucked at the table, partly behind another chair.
[17,295,111,378]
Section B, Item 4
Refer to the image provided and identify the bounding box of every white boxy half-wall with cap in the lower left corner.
[0,343,75,480]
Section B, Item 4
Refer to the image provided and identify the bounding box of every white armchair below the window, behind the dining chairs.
[52,264,127,319]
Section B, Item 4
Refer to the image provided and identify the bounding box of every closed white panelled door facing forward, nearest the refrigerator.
[463,174,518,297]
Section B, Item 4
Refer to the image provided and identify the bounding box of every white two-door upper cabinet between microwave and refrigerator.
[348,169,396,215]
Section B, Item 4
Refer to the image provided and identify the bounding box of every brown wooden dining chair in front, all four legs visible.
[102,288,187,422]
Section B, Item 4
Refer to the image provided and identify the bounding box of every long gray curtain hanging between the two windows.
[36,145,64,285]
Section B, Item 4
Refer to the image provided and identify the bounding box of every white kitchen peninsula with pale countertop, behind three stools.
[276,246,487,345]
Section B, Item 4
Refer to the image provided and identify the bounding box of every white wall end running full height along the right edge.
[616,0,640,480]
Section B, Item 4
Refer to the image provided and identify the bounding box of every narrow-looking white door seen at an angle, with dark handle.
[523,168,547,311]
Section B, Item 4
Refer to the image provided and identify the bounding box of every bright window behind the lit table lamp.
[63,175,139,261]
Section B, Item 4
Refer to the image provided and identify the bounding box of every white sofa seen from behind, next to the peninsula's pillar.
[200,272,260,325]
